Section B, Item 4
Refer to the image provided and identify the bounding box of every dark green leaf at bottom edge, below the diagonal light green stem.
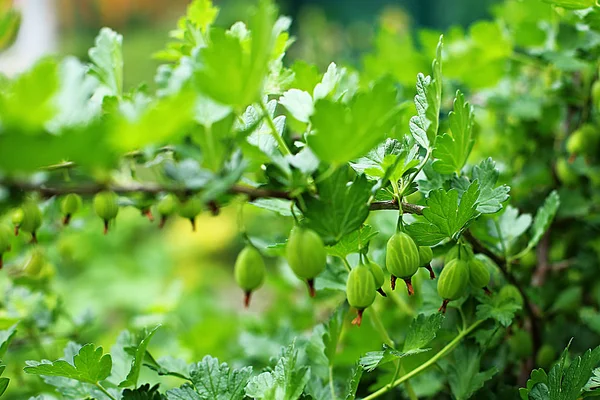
[443,345,498,400]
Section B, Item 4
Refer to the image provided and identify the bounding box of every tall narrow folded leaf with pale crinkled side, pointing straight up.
[410,36,443,149]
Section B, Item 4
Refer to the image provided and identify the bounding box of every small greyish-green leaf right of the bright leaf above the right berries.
[472,158,510,214]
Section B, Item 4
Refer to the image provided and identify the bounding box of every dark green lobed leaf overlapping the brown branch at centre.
[301,167,372,244]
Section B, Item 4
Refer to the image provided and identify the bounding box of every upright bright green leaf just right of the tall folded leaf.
[433,91,475,174]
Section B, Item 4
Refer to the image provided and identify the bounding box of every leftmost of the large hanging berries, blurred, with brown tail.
[233,246,267,308]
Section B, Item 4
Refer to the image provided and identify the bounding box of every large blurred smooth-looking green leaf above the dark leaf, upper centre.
[307,80,397,166]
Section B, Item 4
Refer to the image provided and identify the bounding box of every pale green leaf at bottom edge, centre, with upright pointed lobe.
[246,343,310,400]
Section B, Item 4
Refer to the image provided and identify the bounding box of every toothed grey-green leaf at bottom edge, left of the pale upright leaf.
[190,356,252,400]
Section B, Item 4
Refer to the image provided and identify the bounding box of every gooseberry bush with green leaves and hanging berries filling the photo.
[0,0,600,400]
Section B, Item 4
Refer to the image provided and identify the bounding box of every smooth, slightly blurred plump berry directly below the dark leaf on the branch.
[285,226,327,297]
